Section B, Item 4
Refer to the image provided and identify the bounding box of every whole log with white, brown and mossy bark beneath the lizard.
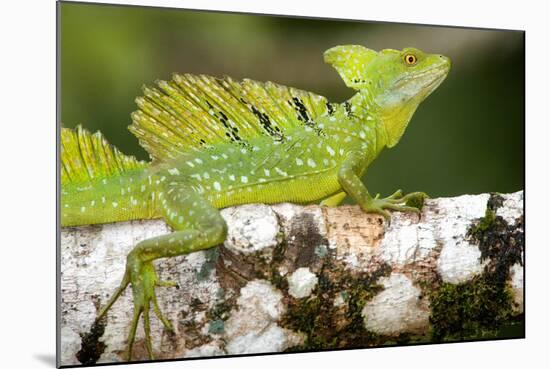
[60,191,523,365]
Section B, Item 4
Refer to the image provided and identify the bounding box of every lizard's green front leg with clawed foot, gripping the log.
[338,152,427,219]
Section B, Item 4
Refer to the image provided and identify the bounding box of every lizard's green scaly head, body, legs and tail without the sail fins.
[61,45,450,360]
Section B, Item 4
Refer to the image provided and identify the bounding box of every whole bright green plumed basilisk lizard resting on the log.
[61,45,450,360]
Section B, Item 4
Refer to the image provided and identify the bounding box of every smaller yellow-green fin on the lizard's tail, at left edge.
[61,125,147,185]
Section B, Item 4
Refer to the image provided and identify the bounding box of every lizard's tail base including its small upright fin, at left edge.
[61,126,155,226]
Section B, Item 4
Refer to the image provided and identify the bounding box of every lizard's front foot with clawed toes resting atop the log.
[362,190,429,219]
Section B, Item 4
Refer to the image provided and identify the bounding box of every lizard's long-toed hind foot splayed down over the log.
[97,253,177,361]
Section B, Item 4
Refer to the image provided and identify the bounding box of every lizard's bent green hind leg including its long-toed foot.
[99,182,227,361]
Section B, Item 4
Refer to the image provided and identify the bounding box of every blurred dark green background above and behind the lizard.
[59,3,525,197]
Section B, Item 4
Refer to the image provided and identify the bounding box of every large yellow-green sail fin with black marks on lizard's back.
[129,74,330,161]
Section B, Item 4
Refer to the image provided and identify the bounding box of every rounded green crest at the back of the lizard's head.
[324,45,378,90]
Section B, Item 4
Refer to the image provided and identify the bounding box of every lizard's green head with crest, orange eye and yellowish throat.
[324,45,451,147]
